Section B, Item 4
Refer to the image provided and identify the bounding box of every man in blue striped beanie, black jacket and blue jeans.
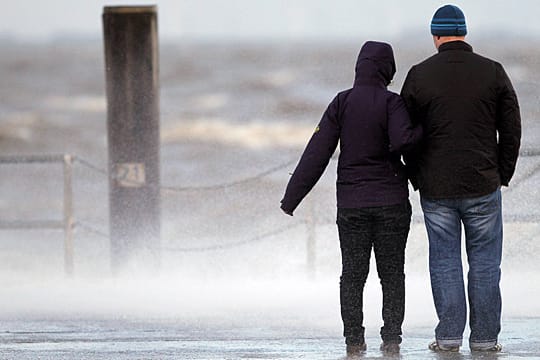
[401,5,521,352]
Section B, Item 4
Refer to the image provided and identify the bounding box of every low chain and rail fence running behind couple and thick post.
[0,149,540,274]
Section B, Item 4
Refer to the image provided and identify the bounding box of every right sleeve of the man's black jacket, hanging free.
[496,63,521,186]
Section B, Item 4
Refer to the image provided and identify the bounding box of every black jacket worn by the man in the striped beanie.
[401,41,521,199]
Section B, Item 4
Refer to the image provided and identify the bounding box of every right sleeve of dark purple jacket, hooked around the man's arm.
[387,94,422,154]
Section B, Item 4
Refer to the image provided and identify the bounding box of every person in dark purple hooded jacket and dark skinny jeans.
[281,41,422,355]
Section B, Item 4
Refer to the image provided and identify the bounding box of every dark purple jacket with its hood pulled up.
[281,41,422,215]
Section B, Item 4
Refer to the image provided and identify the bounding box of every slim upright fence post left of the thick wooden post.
[64,154,73,275]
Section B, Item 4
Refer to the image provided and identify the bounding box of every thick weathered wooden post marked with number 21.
[103,6,160,273]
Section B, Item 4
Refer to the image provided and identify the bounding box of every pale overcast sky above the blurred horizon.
[0,0,540,40]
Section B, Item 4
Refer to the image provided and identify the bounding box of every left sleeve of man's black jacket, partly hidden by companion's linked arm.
[401,66,422,190]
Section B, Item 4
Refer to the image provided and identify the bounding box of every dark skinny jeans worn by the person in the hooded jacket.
[337,201,411,344]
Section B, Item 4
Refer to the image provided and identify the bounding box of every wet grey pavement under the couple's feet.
[0,318,540,359]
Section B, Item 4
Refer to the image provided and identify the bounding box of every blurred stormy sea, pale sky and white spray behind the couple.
[0,0,540,358]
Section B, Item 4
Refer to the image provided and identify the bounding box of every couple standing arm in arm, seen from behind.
[281,5,521,355]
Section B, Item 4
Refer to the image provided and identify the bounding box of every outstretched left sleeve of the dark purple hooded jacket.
[281,96,340,215]
